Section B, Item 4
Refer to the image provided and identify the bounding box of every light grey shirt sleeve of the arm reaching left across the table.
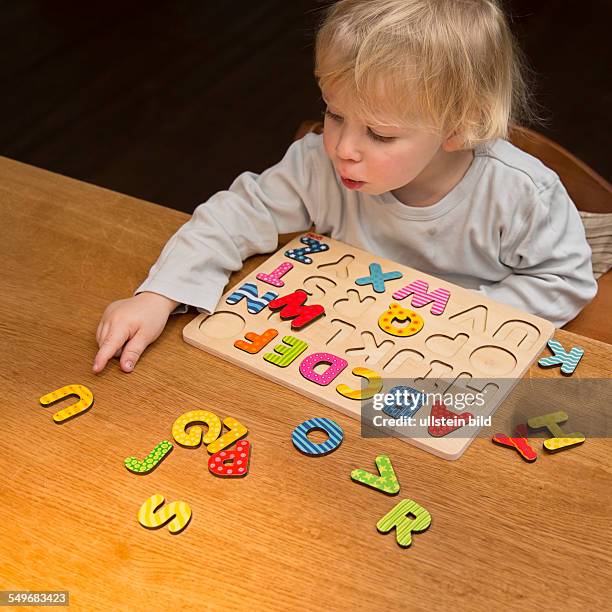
[134,136,318,313]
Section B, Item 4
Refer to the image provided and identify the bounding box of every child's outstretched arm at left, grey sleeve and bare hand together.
[93,135,322,372]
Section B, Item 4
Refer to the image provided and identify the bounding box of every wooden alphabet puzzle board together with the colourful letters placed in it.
[183,233,555,459]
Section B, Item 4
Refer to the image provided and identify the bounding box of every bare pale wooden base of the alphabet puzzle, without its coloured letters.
[183,233,555,459]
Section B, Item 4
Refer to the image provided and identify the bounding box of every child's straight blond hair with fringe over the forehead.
[315,0,529,148]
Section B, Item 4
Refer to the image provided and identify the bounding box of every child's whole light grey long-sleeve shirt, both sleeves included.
[135,134,597,327]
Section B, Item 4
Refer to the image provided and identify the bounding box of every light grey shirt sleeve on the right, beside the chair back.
[478,179,597,327]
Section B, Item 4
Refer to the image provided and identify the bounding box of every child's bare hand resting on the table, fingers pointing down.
[93,291,179,374]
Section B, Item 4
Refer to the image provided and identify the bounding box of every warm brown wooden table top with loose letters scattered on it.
[0,158,612,610]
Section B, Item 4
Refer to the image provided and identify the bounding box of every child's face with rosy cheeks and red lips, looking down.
[323,95,444,195]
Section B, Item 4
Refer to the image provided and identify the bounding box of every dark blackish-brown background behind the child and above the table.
[0,0,612,212]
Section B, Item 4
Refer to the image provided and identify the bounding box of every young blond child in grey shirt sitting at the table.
[93,0,597,372]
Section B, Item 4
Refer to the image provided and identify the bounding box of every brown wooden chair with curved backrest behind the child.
[294,121,612,344]
